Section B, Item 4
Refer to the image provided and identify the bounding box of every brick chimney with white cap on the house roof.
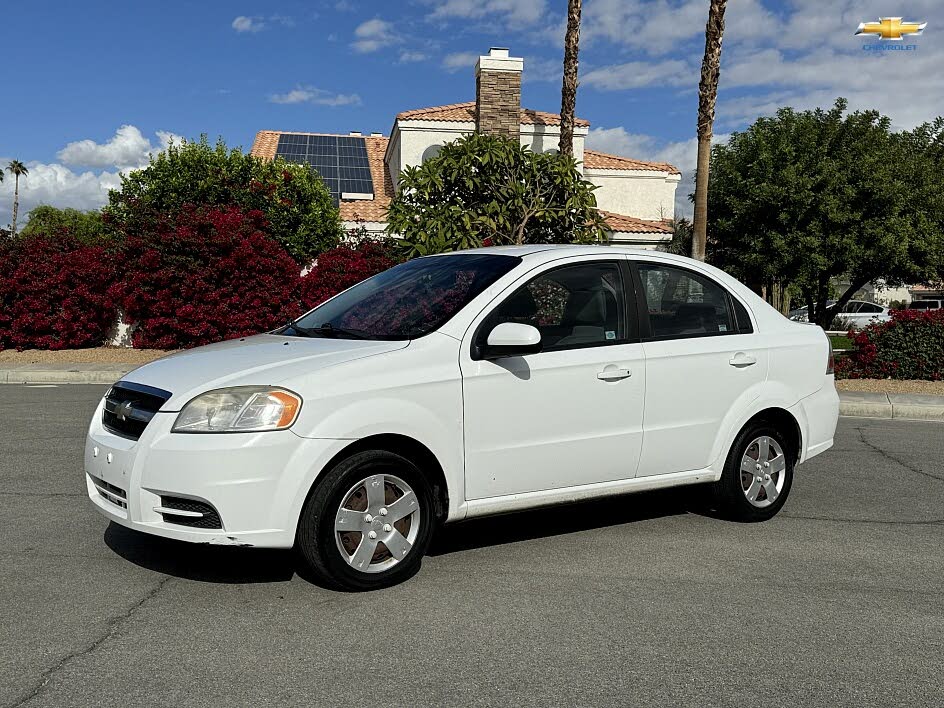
[475,47,524,138]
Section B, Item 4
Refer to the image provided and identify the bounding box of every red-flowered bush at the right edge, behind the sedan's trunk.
[836,310,944,381]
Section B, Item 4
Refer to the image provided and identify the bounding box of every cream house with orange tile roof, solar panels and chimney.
[252,48,681,248]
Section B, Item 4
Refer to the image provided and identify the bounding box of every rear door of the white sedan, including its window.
[634,261,768,477]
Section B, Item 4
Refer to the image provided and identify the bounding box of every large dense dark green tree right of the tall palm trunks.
[708,99,944,327]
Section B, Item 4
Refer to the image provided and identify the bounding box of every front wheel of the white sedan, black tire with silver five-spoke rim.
[296,450,436,591]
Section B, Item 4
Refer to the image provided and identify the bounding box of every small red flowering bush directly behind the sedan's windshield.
[300,239,397,310]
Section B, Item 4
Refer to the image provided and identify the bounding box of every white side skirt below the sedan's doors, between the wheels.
[449,469,721,521]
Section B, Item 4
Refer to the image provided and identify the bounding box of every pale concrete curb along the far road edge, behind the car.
[0,362,944,422]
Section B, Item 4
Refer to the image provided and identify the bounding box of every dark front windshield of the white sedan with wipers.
[281,253,521,339]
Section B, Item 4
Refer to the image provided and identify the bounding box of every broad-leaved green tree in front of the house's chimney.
[387,133,605,257]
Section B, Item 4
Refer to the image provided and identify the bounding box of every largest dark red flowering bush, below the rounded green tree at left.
[111,207,299,349]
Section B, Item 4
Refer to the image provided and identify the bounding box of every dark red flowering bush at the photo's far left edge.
[0,233,117,349]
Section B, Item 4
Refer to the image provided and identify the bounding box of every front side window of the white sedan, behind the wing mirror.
[485,263,627,351]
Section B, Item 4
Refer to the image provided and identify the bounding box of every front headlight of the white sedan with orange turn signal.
[172,386,302,433]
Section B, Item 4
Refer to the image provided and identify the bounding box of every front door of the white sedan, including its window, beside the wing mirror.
[460,258,645,499]
